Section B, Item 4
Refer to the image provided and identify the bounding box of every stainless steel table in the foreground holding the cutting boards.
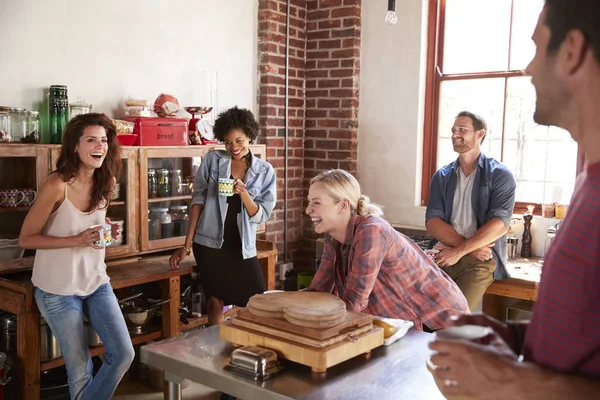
[141,326,444,400]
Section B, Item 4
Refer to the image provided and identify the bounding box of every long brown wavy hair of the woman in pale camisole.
[54,113,122,213]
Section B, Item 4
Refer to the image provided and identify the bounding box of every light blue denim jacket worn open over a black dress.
[192,150,277,259]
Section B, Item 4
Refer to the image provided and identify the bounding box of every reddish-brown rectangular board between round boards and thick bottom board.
[237,308,373,340]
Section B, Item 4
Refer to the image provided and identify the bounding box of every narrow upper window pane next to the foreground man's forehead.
[510,0,544,70]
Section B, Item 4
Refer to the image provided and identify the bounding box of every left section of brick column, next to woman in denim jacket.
[258,0,306,260]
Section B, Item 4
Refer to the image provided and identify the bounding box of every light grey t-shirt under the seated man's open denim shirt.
[450,166,477,239]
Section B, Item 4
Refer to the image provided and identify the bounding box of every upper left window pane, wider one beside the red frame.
[442,0,510,74]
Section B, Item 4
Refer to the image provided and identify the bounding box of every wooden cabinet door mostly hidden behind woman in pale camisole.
[50,146,140,259]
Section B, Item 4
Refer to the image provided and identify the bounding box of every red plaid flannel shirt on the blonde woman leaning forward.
[309,215,469,330]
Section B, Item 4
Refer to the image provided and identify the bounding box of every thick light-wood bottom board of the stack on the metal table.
[219,321,383,372]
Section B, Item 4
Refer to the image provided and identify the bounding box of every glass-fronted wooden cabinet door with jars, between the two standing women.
[139,146,210,251]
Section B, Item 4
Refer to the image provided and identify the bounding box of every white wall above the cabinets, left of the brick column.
[0,0,258,115]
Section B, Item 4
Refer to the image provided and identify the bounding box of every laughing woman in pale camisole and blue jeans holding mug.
[19,113,134,400]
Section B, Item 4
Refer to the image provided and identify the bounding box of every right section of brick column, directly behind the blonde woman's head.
[302,0,361,268]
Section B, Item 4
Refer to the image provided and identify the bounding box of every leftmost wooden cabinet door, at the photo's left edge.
[0,144,48,261]
